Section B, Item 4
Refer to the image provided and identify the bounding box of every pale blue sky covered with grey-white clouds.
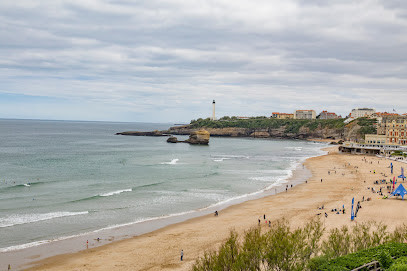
[0,0,407,123]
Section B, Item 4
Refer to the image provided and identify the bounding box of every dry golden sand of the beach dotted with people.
[22,146,407,270]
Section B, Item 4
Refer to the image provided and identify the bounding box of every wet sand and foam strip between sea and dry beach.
[0,143,326,269]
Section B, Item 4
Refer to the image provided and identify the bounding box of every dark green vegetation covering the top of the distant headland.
[190,117,345,133]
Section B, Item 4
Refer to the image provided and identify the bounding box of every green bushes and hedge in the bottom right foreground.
[192,220,407,271]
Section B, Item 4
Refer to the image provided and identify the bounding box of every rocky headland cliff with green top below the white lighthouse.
[117,118,375,141]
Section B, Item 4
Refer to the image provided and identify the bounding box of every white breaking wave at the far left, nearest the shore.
[0,211,89,228]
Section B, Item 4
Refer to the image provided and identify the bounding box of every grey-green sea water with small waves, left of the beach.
[0,120,323,252]
